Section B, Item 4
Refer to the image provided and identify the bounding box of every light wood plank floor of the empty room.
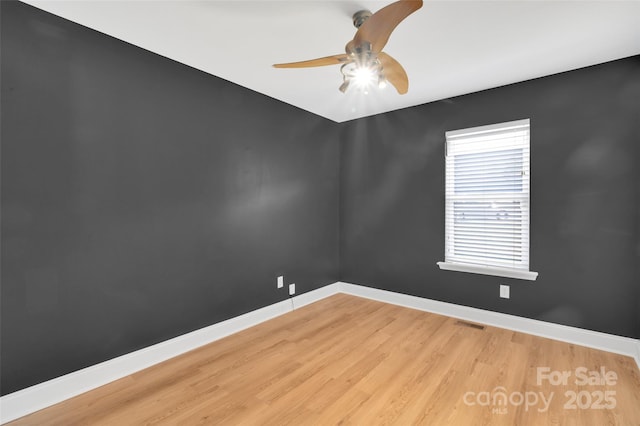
[11,294,640,426]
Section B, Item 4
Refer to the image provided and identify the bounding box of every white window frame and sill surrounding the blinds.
[437,119,538,281]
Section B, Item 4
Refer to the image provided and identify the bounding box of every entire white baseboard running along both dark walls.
[0,282,640,423]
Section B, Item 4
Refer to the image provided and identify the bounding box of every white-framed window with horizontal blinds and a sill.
[438,120,538,280]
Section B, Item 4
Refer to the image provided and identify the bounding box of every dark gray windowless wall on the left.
[0,1,339,394]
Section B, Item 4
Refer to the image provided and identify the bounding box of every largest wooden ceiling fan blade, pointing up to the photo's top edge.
[347,0,422,52]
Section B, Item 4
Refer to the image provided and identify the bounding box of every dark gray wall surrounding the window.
[340,56,640,338]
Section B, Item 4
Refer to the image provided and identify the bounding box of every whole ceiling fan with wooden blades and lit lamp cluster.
[273,0,422,95]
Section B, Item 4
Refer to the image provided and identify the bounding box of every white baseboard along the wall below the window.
[338,282,640,369]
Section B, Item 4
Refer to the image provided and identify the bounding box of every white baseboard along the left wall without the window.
[0,284,338,424]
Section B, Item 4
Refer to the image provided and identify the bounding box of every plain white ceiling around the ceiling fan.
[20,0,640,122]
